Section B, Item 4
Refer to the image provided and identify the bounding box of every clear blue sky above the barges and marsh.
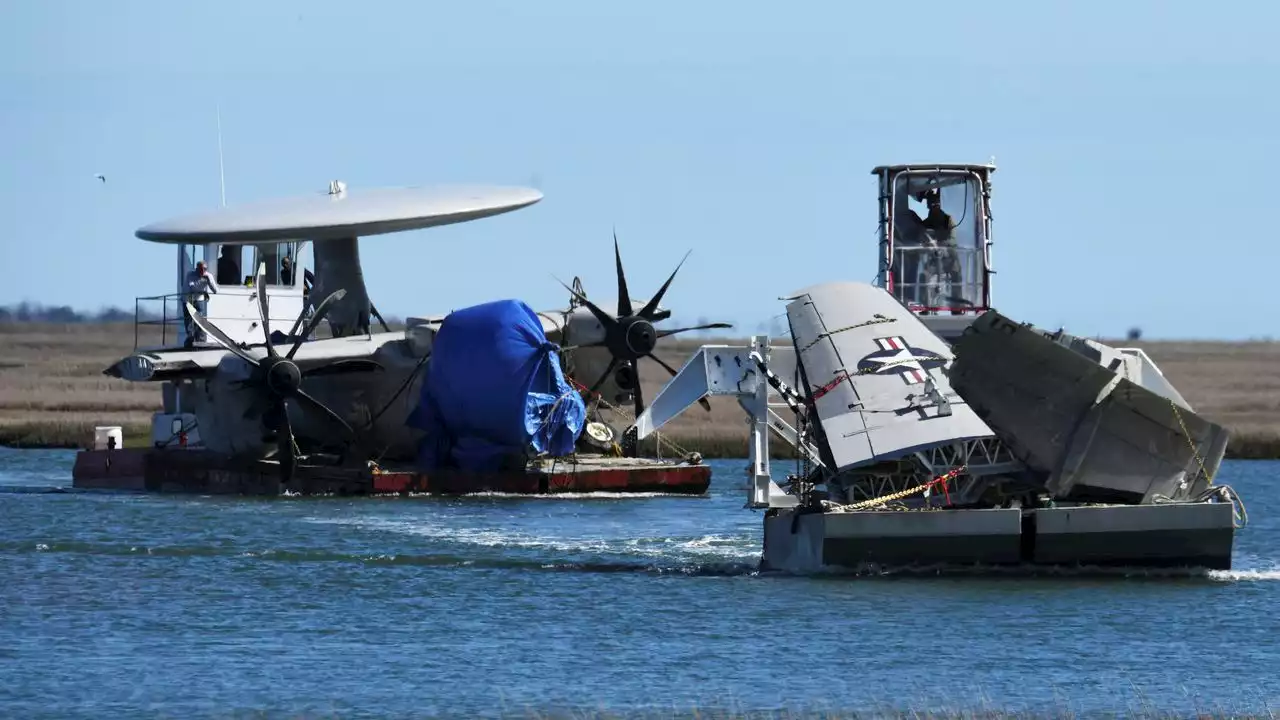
[0,0,1280,338]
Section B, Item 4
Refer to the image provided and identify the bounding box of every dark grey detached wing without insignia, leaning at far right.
[951,310,1229,502]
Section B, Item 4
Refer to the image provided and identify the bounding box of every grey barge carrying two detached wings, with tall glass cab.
[637,164,1244,571]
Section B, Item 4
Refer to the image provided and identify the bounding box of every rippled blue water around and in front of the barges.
[0,450,1280,717]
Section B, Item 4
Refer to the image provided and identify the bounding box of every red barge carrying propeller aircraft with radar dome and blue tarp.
[73,182,728,495]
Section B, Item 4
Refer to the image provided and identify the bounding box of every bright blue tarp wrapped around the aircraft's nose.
[407,300,586,471]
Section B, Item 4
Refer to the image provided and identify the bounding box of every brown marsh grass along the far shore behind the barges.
[0,323,1280,459]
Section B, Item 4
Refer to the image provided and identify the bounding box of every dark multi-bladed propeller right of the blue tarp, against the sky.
[557,231,733,418]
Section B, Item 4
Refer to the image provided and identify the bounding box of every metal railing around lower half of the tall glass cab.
[890,243,986,313]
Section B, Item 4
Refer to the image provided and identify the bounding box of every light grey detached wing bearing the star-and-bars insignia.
[787,282,995,470]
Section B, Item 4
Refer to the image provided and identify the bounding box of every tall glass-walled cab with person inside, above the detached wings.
[872,164,996,340]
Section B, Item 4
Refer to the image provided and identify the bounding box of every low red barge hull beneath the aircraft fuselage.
[72,448,712,496]
